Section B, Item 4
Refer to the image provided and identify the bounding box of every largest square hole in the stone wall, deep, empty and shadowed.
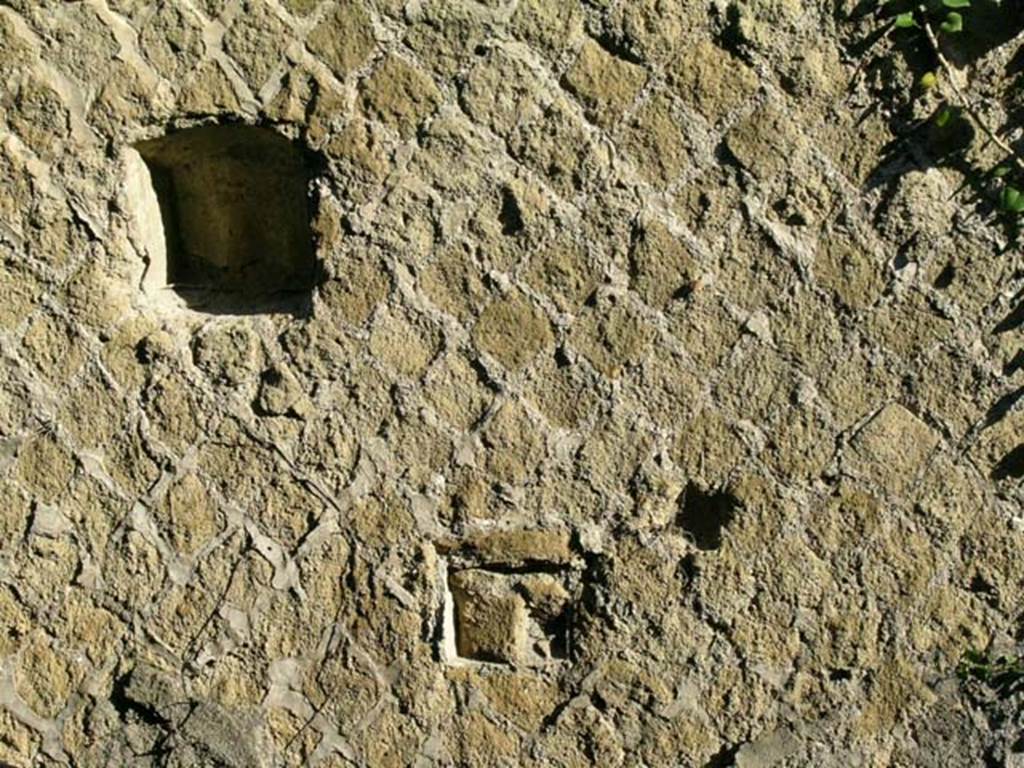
[128,125,316,313]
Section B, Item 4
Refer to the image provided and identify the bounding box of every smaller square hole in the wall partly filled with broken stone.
[440,536,580,667]
